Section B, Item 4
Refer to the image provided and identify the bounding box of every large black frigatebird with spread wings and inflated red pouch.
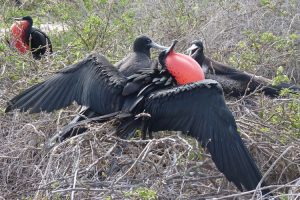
[6,42,269,194]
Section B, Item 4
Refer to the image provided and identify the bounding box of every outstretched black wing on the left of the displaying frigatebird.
[6,54,127,114]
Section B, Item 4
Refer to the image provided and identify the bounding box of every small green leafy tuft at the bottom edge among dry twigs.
[125,187,158,200]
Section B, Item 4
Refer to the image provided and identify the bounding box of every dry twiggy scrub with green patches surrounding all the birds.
[0,0,300,199]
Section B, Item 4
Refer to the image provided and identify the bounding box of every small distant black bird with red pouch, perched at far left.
[10,16,52,59]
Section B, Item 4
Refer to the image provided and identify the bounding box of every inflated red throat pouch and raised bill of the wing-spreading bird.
[164,41,205,85]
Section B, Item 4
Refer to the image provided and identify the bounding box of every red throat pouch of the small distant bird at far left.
[10,20,30,54]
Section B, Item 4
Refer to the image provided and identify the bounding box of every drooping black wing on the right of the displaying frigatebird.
[145,80,268,194]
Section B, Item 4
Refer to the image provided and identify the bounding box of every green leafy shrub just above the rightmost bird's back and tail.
[229,30,298,74]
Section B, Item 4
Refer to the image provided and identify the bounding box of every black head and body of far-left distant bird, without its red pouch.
[12,16,53,59]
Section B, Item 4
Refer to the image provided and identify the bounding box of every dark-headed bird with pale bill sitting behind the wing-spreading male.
[55,36,167,141]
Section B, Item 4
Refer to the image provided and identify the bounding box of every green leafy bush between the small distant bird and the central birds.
[47,0,135,53]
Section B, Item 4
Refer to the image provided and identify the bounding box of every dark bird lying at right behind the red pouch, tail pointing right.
[187,40,300,97]
